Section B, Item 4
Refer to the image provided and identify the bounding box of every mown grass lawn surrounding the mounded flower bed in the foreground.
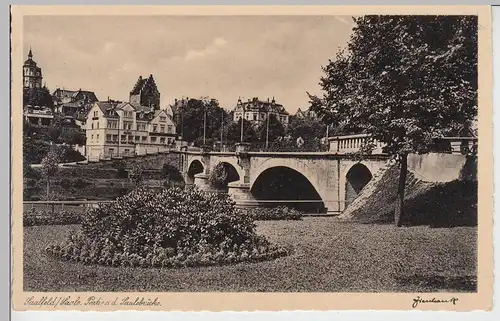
[24,217,477,292]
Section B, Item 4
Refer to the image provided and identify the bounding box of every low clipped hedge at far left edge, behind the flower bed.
[23,209,82,226]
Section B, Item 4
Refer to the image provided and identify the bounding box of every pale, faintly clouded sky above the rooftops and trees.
[23,16,353,113]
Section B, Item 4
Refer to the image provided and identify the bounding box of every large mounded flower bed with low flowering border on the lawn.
[45,188,288,267]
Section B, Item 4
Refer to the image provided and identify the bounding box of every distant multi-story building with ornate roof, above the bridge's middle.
[232,97,290,126]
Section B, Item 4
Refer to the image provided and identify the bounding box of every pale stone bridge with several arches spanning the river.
[86,135,471,214]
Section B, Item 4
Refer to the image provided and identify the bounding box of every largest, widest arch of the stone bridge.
[250,160,325,212]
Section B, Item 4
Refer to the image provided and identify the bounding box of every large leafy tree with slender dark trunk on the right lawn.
[310,16,478,226]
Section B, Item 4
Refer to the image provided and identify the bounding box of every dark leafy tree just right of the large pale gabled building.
[177,98,228,142]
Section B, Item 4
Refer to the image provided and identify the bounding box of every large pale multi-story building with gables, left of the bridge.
[85,101,177,161]
